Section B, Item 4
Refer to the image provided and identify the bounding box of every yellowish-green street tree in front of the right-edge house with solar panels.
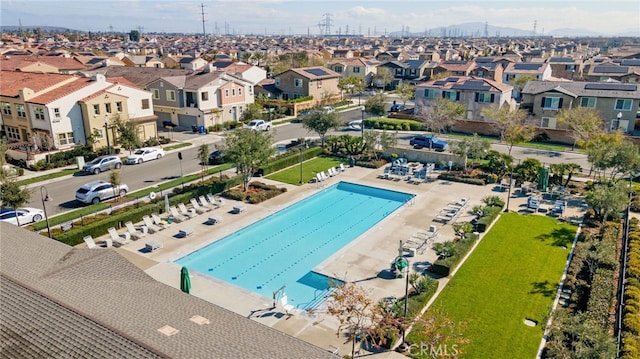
[557,107,604,148]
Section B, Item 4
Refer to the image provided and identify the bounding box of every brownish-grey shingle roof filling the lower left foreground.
[0,222,337,359]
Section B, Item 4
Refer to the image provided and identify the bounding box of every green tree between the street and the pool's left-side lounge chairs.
[220,128,276,191]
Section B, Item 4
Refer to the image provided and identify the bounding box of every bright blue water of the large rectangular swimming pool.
[176,182,413,309]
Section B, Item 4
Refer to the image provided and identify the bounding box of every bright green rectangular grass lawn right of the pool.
[408,212,576,358]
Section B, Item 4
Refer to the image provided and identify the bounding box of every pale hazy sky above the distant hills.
[0,0,640,36]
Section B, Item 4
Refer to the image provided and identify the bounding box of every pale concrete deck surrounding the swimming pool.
[96,167,585,358]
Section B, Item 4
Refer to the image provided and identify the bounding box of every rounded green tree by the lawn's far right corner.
[585,182,629,223]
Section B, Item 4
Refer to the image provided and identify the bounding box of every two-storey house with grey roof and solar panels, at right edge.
[521,81,640,133]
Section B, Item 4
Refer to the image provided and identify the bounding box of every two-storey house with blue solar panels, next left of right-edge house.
[414,76,513,120]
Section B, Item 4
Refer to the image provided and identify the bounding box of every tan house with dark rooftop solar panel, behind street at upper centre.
[274,67,341,103]
